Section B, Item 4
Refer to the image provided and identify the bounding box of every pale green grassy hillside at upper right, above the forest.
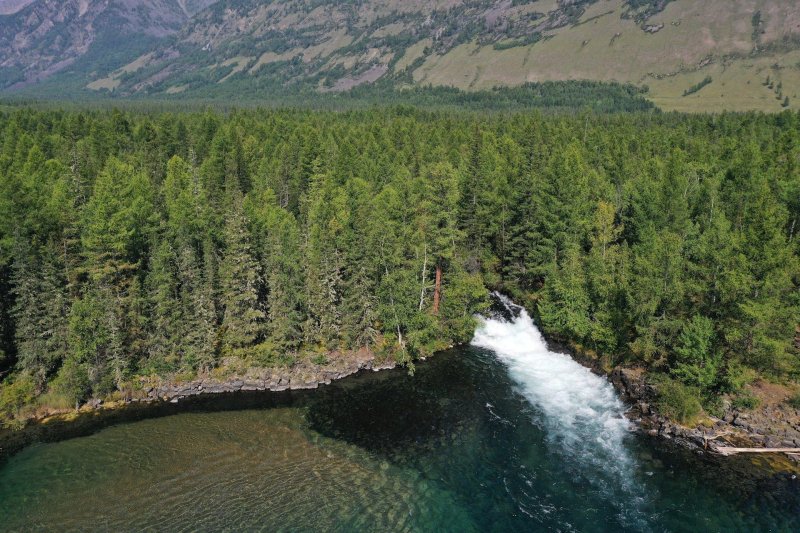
[414,0,800,111]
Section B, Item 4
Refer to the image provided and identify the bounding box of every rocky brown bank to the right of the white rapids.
[549,341,800,472]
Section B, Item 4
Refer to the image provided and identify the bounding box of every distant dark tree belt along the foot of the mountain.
[0,80,657,113]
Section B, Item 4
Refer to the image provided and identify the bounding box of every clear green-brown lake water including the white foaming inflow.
[0,304,800,532]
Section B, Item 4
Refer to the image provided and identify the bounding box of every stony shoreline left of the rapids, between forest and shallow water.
[0,349,397,461]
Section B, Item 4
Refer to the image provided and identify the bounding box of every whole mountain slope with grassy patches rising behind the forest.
[0,0,800,111]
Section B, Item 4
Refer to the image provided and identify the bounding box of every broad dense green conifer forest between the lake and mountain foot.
[0,108,800,423]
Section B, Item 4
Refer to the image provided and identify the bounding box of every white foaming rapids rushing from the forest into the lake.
[472,294,643,524]
